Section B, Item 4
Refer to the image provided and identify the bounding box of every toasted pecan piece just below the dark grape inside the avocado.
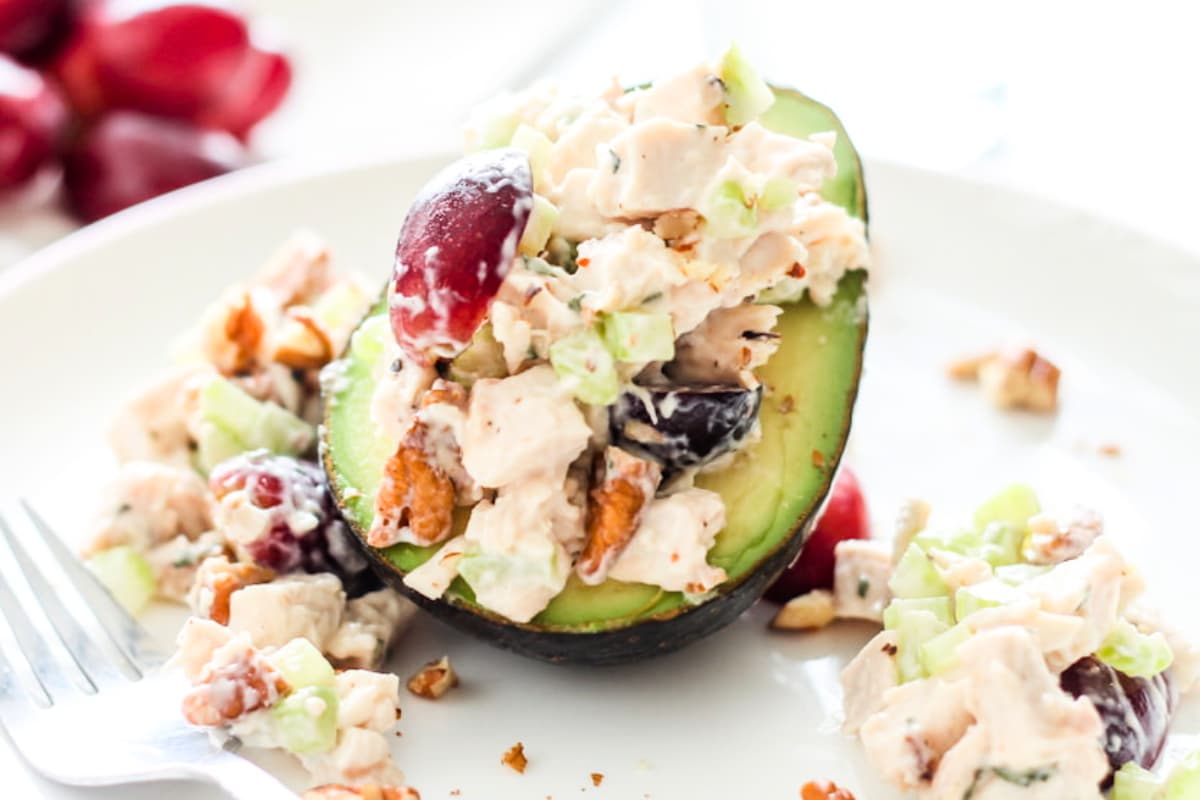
[575,447,662,585]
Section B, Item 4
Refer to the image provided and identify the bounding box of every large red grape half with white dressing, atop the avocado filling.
[390,148,533,363]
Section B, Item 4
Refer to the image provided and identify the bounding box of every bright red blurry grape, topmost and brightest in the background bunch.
[55,0,292,136]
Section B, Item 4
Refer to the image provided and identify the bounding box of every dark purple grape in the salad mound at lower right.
[1060,656,1180,770]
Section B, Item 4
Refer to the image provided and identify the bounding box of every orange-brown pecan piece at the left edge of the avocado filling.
[367,420,455,547]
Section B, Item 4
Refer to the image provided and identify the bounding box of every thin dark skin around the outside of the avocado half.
[322,88,868,666]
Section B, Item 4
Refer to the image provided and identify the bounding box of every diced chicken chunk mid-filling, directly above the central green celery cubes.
[570,227,688,312]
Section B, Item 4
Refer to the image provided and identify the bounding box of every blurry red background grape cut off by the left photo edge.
[0,55,67,192]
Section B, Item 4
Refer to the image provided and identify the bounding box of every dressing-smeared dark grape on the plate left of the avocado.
[209,451,380,597]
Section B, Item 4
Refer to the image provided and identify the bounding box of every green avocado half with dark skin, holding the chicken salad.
[322,89,868,664]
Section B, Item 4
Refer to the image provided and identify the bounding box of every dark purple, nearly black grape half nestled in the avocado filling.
[610,386,762,474]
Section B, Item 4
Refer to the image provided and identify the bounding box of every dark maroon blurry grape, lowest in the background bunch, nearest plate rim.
[64,112,248,222]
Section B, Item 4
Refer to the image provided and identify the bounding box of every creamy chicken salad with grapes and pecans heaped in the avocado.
[350,53,869,622]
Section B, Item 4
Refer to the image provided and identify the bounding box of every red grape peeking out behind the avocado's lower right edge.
[766,467,871,603]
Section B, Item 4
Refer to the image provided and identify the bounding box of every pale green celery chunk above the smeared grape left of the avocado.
[199,378,317,471]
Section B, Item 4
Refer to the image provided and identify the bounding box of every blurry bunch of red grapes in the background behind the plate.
[0,0,292,222]
